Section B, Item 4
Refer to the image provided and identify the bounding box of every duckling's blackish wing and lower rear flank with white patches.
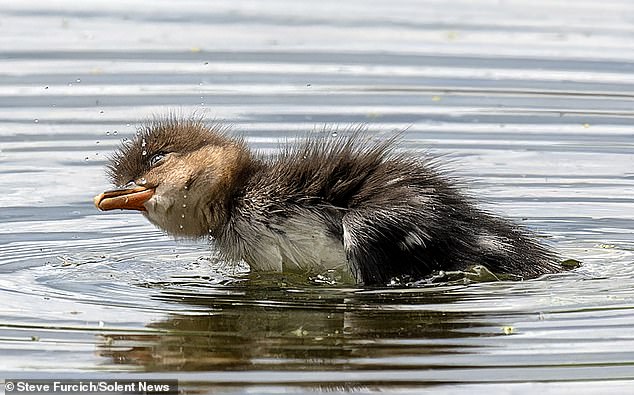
[342,204,561,285]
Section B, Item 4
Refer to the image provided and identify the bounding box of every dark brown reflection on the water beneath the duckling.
[99,284,474,371]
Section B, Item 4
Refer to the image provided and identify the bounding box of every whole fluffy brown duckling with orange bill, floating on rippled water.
[95,119,558,285]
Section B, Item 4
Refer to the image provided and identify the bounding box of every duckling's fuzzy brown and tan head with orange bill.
[94,119,251,237]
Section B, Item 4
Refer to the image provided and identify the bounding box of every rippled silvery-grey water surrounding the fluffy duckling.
[0,1,634,394]
